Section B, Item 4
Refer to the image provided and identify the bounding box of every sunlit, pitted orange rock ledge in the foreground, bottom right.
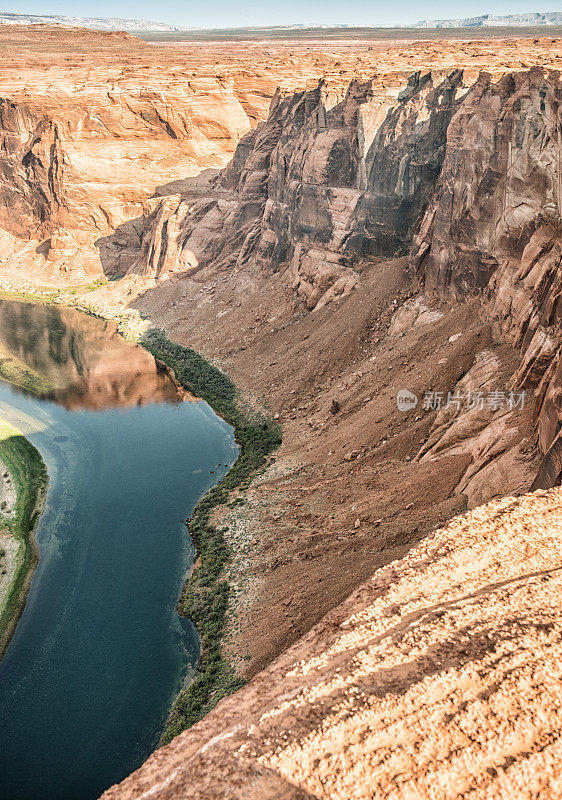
[103,489,562,800]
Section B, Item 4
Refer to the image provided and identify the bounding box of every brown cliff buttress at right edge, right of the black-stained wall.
[411,69,562,486]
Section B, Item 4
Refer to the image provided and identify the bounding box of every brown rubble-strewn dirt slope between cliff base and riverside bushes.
[117,259,538,674]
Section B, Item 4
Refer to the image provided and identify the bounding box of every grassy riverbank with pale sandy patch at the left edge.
[0,419,48,658]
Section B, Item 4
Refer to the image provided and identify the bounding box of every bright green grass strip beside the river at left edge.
[0,419,48,657]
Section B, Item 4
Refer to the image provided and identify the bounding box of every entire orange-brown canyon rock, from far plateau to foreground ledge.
[0,26,562,798]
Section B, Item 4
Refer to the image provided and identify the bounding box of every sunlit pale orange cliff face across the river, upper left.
[0,82,250,276]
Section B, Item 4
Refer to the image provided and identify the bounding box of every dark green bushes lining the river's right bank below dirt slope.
[139,330,281,744]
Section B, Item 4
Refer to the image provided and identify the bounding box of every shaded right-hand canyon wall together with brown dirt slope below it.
[99,59,559,692]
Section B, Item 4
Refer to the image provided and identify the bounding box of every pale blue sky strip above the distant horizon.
[3,0,562,28]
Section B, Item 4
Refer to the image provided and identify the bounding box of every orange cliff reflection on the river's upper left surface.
[0,299,185,410]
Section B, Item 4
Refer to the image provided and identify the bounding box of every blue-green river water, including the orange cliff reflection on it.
[0,301,237,800]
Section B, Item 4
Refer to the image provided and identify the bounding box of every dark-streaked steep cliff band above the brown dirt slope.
[131,65,559,316]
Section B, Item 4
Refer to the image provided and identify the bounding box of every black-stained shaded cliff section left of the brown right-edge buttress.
[133,70,466,309]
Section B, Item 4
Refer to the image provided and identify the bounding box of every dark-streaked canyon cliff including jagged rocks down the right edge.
[131,68,562,489]
